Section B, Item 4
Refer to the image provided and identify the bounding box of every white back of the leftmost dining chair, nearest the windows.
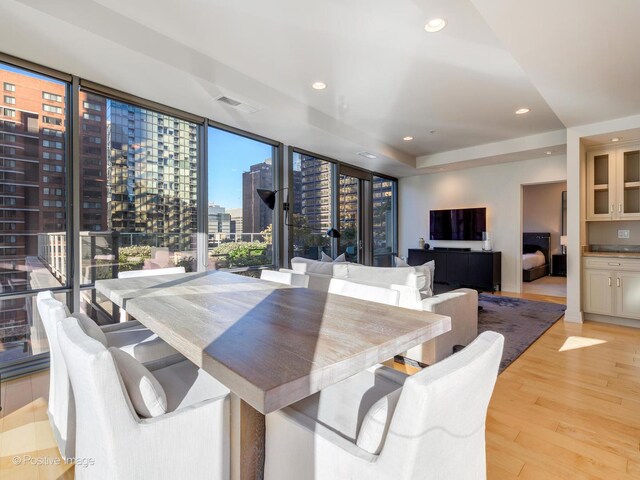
[36,290,75,459]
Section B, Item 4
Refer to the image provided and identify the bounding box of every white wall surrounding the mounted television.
[398,155,567,292]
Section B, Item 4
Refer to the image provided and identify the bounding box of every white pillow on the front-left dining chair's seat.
[109,347,167,418]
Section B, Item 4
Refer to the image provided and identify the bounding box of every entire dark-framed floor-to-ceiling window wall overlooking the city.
[0,52,396,374]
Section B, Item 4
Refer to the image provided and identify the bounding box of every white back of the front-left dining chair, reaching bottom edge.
[58,317,139,478]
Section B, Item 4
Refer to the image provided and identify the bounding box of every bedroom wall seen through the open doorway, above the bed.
[522,182,567,258]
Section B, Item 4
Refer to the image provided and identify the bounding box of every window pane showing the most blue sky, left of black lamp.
[207,127,276,270]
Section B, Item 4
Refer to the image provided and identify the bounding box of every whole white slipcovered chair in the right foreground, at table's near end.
[264,332,504,480]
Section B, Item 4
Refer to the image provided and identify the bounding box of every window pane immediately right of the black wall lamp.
[289,152,335,260]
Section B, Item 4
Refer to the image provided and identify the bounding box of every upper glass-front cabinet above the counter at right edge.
[586,144,640,220]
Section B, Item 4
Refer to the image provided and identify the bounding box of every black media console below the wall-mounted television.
[408,248,502,292]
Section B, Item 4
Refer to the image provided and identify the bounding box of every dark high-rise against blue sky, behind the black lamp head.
[242,158,273,233]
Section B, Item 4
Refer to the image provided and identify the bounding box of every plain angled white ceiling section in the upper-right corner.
[471,0,640,127]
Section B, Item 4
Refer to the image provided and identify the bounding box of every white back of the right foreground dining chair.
[380,332,504,480]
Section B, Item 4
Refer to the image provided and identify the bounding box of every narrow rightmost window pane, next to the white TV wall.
[372,175,398,267]
